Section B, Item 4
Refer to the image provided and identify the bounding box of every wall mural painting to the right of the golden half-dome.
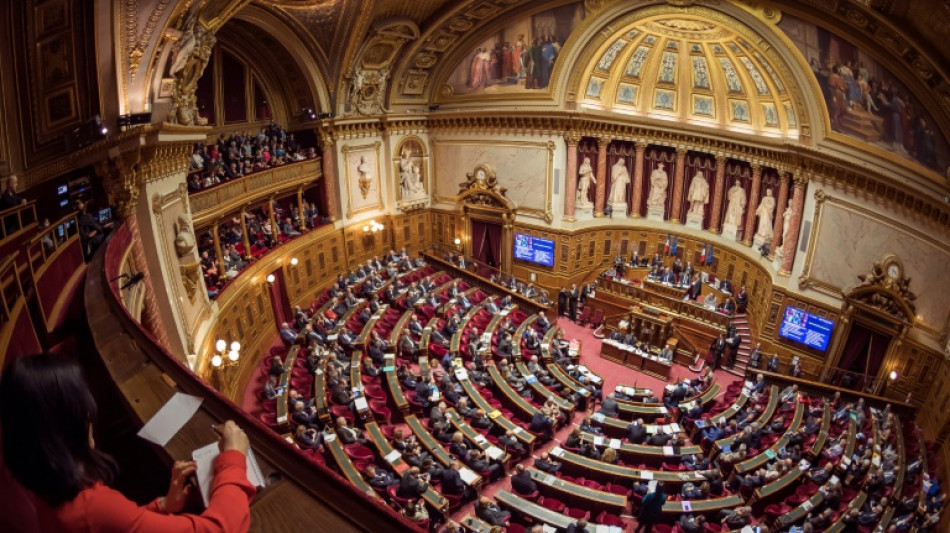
[779,16,950,172]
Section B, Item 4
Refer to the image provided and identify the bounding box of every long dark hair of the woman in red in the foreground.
[0,353,117,507]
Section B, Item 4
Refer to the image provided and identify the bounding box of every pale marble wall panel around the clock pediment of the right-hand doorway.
[805,192,950,331]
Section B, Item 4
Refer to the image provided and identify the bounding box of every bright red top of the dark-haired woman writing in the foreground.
[58,450,257,533]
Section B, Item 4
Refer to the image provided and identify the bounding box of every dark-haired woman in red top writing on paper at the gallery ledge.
[0,354,256,533]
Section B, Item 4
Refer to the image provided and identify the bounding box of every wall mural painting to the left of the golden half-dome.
[447,2,588,94]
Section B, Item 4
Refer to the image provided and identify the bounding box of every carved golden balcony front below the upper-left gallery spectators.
[188,159,323,226]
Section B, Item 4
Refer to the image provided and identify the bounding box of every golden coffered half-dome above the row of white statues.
[577,14,798,139]
